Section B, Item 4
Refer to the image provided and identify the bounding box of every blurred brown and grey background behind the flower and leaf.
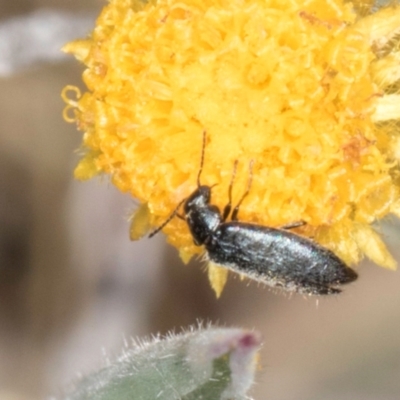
[0,0,400,400]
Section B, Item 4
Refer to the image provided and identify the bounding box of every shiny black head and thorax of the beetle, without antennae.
[184,186,222,246]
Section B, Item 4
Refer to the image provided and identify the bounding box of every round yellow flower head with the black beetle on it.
[63,0,400,291]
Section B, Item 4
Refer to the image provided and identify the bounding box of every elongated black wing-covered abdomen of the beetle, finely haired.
[206,222,357,294]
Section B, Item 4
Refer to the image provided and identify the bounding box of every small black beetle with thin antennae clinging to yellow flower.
[150,132,358,295]
